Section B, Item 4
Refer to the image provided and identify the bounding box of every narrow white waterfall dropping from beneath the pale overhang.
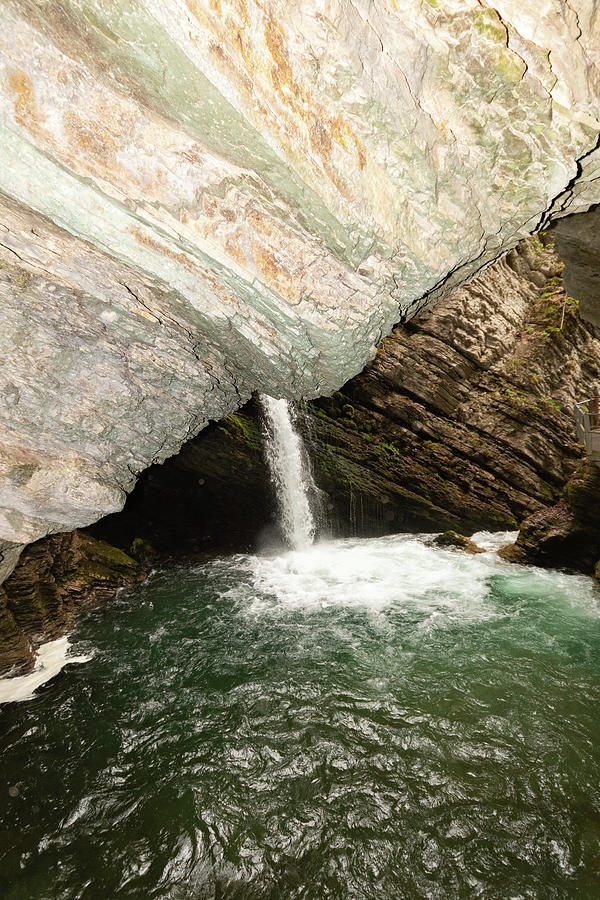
[260,394,315,550]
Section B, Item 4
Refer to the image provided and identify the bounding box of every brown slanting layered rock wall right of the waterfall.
[304,234,600,534]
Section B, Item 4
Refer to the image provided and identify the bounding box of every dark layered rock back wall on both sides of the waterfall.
[94,233,600,555]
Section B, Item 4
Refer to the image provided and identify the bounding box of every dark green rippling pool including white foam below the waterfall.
[0,536,600,900]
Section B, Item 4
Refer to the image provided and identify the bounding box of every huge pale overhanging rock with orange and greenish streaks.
[0,0,600,568]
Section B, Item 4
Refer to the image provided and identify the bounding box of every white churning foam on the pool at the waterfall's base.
[220,532,600,620]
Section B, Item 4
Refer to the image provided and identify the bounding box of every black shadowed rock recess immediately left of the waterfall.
[89,412,276,557]
